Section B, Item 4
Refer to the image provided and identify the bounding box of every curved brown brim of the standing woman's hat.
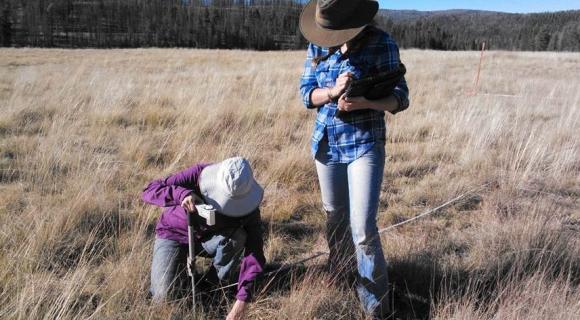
[300,0,379,48]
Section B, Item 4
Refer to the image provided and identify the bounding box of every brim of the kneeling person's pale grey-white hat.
[199,163,264,218]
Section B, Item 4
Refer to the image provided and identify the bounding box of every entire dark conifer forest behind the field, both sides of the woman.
[0,0,580,51]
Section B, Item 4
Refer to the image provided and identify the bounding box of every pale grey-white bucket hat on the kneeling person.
[199,157,264,218]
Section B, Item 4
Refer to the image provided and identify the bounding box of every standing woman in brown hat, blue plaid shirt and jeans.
[300,0,409,317]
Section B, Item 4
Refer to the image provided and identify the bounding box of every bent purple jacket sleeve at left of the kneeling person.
[142,164,204,207]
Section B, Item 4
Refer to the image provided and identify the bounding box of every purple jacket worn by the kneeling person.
[142,163,266,301]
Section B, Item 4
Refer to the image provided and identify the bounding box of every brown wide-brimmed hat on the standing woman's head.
[300,0,379,48]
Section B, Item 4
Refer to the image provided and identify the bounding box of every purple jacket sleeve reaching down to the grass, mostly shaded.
[236,210,266,301]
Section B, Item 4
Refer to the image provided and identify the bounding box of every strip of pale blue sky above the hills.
[379,0,580,13]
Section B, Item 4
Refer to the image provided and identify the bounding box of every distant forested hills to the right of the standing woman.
[380,11,580,51]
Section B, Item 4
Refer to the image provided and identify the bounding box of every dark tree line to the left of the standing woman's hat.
[0,0,304,50]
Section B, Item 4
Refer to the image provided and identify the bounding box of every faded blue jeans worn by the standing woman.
[316,140,388,313]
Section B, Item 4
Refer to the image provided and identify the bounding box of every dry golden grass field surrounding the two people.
[0,49,580,320]
